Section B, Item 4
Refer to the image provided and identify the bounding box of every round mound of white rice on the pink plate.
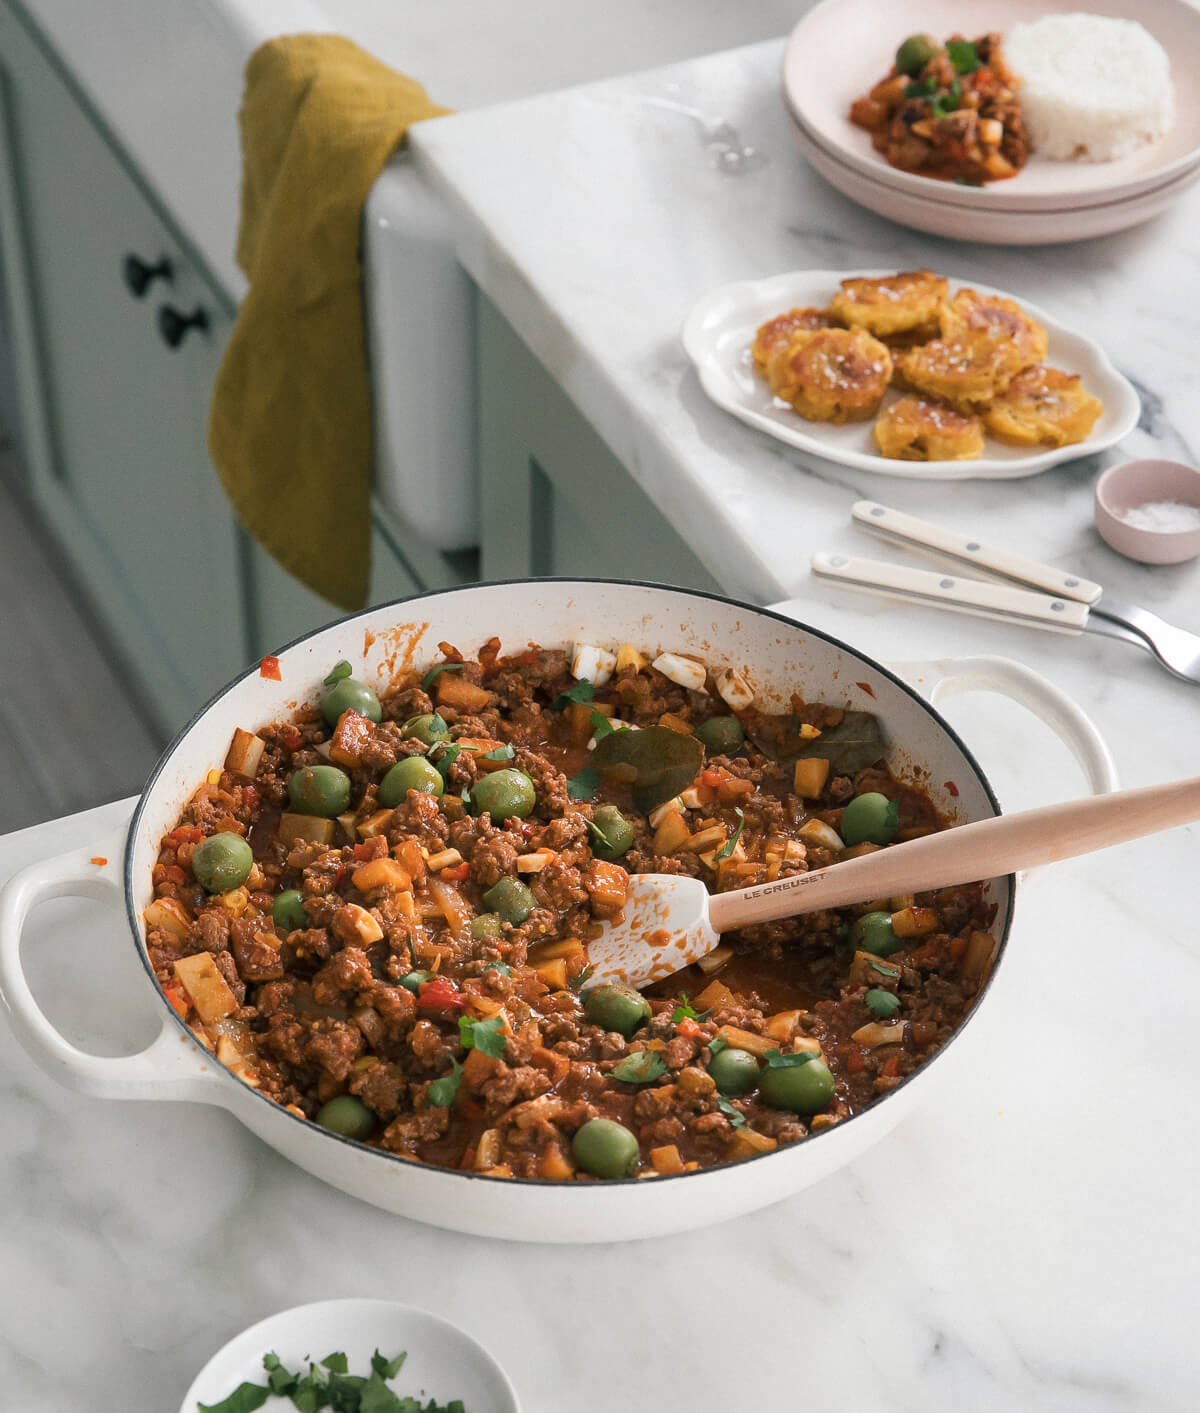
[1004,14,1175,162]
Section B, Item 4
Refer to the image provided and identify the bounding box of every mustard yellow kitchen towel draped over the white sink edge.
[208,34,449,609]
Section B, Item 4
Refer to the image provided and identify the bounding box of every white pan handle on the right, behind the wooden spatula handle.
[888,657,1119,794]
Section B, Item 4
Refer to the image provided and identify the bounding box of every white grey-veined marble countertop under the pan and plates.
[7,27,1200,1413]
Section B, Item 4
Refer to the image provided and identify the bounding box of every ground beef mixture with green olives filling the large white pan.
[146,640,994,1181]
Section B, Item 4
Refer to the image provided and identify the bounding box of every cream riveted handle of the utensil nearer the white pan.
[813,552,1090,633]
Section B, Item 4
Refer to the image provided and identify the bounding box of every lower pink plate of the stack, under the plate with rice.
[790,111,1200,246]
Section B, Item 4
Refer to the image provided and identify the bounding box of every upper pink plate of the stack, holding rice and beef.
[783,0,1200,211]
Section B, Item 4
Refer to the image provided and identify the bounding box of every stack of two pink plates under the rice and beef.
[783,0,1200,246]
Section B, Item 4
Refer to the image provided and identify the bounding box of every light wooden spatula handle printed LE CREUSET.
[710,777,1200,933]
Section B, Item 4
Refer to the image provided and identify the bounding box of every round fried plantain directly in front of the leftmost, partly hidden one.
[767,329,892,422]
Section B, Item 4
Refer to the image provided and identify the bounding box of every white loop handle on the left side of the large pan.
[0,827,219,1102]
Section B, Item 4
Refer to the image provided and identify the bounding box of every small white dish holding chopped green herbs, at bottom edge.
[180,1300,520,1413]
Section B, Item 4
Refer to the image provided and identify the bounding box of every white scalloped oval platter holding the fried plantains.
[683,270,1141,480]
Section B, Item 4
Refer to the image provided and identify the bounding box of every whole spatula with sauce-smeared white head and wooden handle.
[585,777,1200,988]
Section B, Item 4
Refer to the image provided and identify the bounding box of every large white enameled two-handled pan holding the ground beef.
[0,579,1115,1241]
